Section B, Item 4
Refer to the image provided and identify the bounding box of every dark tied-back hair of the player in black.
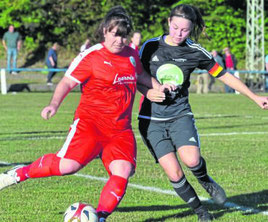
[169,4,208,41]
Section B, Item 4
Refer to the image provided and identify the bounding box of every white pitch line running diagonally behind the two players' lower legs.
[74,173,268,216]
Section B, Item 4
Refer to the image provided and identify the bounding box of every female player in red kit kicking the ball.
[0,6,173,221]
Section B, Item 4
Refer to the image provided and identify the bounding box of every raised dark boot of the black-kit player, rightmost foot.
[199,177,227,204]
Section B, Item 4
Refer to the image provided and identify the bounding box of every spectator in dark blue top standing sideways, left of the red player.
[46,42,59,86]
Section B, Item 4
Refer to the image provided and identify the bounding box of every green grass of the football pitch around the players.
[0,93,268,222]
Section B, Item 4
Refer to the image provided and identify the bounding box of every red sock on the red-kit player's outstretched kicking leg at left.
[16,154,62,182]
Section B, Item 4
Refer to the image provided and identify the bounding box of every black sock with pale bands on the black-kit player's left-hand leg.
[170,176,201,209]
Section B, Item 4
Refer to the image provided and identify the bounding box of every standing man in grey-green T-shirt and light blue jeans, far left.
[2,25,21,75]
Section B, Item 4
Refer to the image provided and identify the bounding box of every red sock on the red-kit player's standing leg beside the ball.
[97,175,128,214]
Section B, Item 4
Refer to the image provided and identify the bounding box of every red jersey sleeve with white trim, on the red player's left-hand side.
[65,53,92,84]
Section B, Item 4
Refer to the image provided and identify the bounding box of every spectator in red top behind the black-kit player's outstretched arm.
[223,47,237,93]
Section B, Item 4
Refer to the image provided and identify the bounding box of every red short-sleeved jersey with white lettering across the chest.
[65,44,142,129]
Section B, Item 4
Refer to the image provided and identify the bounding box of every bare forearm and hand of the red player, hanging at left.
[41,76,78,120]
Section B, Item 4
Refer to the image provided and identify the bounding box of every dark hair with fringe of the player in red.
[97,6,132,41]
